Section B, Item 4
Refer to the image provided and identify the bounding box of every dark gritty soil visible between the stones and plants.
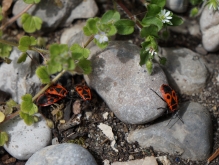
[0,0,219,165]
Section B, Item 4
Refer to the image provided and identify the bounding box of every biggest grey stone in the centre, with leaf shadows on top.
[84,41,167,124]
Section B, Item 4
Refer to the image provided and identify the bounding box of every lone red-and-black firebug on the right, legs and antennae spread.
[151,84,184,125]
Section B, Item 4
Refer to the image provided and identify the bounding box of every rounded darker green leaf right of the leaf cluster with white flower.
[114,19,135,35]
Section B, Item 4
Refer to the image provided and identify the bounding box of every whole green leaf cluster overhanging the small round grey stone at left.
[19,94,38,125]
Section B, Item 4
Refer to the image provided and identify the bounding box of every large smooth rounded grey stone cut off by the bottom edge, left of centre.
[25,143,97,165]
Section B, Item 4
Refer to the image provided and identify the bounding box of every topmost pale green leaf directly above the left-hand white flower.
[100,10,120,24]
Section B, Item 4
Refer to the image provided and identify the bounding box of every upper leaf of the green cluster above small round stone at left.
[21,94,38,115]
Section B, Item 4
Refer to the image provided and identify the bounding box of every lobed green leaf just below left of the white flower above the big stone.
[70,44,90,60]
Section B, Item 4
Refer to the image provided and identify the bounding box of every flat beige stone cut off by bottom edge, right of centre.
[111,156,158,165]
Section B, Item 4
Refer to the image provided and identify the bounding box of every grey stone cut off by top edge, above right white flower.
[166,0,188,13]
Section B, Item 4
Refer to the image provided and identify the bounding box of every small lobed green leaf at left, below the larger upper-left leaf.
[18,36,37,52]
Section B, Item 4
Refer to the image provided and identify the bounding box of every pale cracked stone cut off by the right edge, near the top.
[200,7,219,52]
